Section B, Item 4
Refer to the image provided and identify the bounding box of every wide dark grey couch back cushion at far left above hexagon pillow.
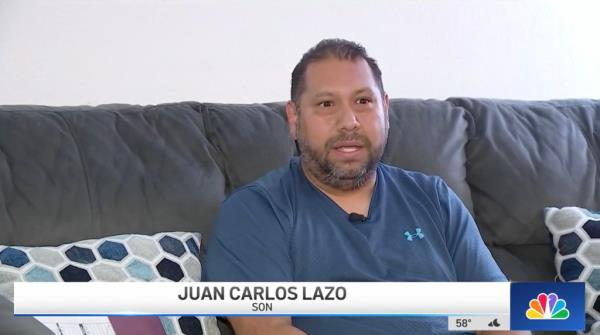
[0,103,224,246]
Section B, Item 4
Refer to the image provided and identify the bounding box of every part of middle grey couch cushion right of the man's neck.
[383,99,473,213]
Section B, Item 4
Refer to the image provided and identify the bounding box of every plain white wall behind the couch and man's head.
[0,0,600,105]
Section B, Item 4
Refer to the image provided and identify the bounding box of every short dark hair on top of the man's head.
[291,38,384,104]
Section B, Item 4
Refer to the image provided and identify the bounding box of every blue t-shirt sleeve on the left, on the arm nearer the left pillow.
[203,187,293,281]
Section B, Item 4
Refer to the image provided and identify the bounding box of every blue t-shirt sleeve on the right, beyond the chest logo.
[436,179,506,282]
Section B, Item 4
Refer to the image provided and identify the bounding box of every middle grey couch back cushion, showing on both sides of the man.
[203,99,472,209]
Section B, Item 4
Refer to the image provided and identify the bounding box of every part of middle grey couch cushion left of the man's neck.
[204,103,294,193]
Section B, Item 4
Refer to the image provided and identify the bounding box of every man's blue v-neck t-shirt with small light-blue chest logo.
[203,158,506,335]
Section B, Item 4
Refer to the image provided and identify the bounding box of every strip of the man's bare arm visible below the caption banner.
[228,316,306,335]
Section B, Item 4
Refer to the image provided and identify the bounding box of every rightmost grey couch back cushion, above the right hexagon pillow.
[449,98,600,245]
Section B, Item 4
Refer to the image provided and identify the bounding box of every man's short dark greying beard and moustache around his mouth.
[296,124,387,191]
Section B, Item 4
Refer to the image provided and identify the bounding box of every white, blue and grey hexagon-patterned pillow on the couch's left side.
[0,232,219,335]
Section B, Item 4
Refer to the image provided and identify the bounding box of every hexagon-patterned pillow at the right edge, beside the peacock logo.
[545,207,600,334]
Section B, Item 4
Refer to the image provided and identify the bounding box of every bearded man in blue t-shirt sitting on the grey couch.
[205,39,524,335]
